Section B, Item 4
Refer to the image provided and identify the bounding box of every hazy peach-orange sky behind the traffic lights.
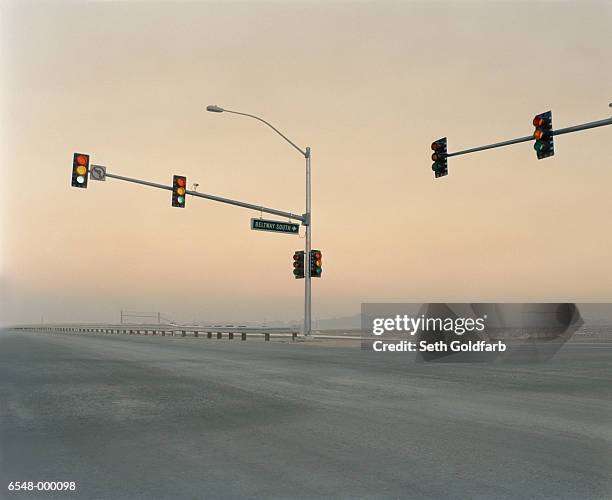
[0,1,612,324]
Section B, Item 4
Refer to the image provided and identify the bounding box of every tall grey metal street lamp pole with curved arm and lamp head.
[206,104,312,337]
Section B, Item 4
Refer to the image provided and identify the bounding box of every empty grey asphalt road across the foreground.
[0,331,612,499]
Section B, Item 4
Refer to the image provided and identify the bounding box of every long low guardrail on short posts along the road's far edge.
[11,324,298,342]
